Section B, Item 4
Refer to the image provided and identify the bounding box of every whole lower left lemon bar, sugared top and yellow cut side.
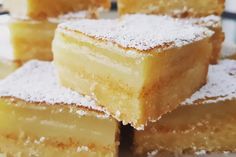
[0,61,119,157]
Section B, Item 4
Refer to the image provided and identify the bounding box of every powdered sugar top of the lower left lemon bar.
[0,61,107,113]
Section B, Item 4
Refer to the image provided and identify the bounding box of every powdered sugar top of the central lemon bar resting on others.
[57,14,213,51]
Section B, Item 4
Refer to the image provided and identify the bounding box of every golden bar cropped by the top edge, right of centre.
[118,0,225,17]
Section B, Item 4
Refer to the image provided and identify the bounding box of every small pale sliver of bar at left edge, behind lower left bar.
[0,58,20,80]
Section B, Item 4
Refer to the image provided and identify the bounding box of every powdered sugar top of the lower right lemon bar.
[182,60,236,105]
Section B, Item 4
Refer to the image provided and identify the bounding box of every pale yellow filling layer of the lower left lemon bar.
[0,99,118,156]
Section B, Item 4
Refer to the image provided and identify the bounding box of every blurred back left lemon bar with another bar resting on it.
[9,11,97,62]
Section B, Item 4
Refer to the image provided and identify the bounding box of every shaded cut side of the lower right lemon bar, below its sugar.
[135,100,236,154]
